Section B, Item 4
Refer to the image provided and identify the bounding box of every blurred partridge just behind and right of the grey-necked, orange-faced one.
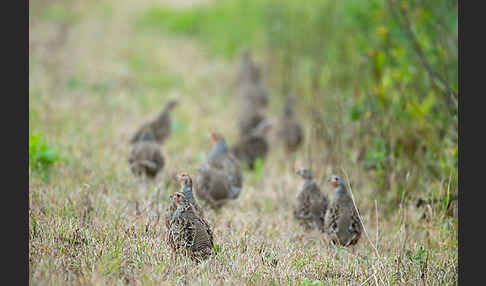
[231,120,271,170]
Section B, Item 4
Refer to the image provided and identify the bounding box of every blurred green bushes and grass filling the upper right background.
[138,0,458,206]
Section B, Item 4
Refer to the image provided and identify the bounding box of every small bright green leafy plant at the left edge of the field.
[29,133,61,177]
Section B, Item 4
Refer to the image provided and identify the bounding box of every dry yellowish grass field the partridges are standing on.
[29,0,458,285]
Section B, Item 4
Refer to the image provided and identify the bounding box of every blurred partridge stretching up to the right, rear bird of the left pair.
[130,99,178,144]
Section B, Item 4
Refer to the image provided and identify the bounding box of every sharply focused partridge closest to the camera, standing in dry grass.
[167,192,214,262]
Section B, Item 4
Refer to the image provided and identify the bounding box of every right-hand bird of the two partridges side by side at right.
[325,175,363,246]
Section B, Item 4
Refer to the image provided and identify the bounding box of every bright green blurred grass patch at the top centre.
[137,0,268,57]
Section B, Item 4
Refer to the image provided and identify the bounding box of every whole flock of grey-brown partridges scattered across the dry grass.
[128,52,363,261]
